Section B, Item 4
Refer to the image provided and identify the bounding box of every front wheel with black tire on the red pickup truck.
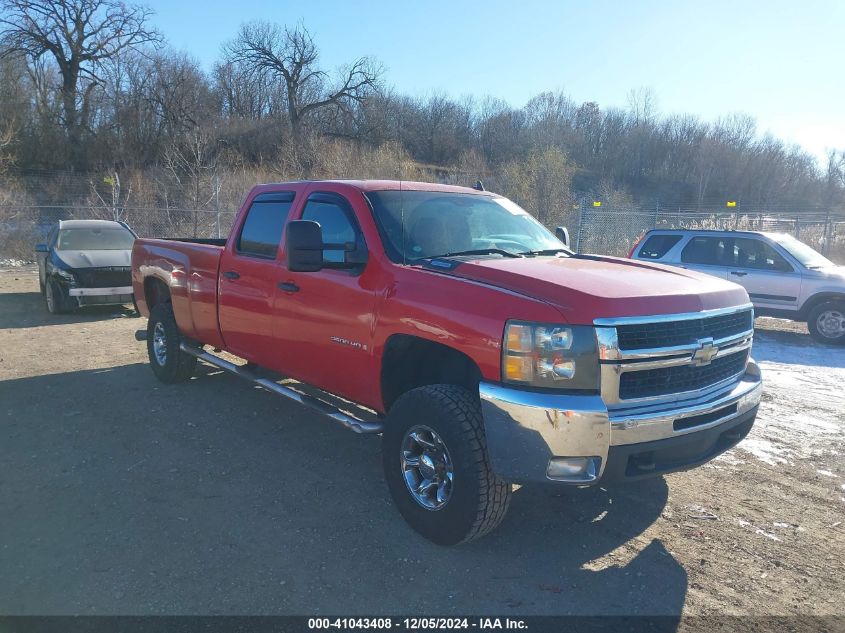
[382,385,512,545]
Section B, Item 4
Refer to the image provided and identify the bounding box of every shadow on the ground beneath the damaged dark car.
[0,292,136,329]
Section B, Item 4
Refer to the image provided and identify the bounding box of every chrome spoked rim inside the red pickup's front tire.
[399,426,454,510]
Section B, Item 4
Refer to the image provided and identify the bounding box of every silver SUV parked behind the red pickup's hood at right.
[629,230,845,345]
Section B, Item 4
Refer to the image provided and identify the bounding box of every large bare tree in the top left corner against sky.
[0,0,159,166]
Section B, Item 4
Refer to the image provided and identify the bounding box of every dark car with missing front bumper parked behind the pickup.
[35,220,136,314]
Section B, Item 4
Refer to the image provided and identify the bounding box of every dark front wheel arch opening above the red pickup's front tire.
[380,334,481,411]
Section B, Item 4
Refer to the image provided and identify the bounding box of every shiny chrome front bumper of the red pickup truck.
[479,360,762,484]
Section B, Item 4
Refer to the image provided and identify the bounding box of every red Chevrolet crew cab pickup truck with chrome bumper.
[132,181,761,544]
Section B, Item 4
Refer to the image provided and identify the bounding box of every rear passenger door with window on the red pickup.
[218,192,294,366]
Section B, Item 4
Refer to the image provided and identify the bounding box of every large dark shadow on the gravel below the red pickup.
[0,363,687,630]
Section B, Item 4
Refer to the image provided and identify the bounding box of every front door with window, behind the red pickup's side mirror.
[274,192,378,406]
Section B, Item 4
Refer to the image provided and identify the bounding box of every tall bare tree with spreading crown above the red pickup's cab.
[224,22,382,152]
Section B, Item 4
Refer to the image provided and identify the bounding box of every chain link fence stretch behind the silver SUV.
[570,204,845,264]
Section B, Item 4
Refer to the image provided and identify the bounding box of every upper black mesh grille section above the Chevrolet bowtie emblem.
[616,309,754,350]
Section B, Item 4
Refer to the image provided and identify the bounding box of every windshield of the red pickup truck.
[366,191,564,263]
